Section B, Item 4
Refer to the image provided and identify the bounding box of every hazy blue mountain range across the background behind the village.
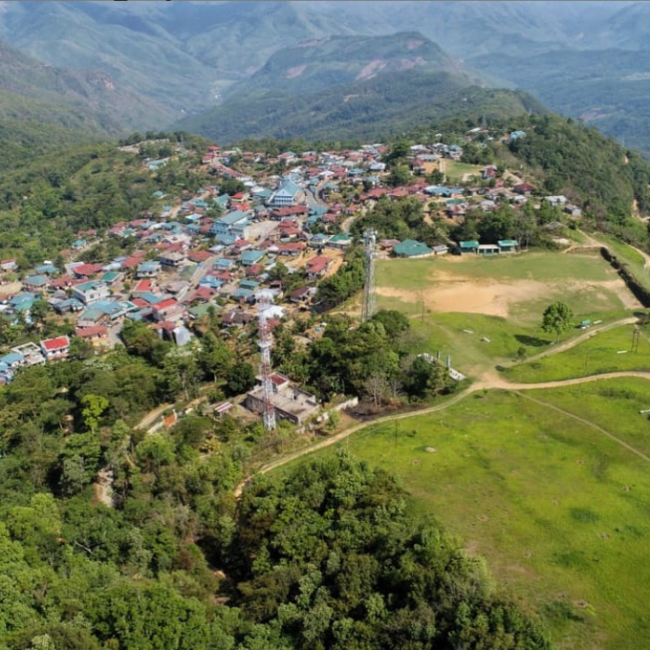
[0,0,650,150]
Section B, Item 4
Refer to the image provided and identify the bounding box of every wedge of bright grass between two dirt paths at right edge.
[505,325,650,383]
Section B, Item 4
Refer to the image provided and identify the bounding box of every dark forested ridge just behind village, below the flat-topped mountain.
[177,70,545,144]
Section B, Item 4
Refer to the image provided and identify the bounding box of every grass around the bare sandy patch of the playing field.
[377,252,629,374]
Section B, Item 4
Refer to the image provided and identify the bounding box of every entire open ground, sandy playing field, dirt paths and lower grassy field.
[253,247,650,650]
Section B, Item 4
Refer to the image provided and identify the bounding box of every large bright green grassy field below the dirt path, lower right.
[280,380,650,650]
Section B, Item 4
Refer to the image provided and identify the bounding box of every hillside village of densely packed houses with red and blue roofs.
[0,129,581,424]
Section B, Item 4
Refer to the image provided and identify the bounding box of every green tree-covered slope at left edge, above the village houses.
[0,137,209,268]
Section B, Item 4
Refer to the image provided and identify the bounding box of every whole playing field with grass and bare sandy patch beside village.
[377,253,639,376]
